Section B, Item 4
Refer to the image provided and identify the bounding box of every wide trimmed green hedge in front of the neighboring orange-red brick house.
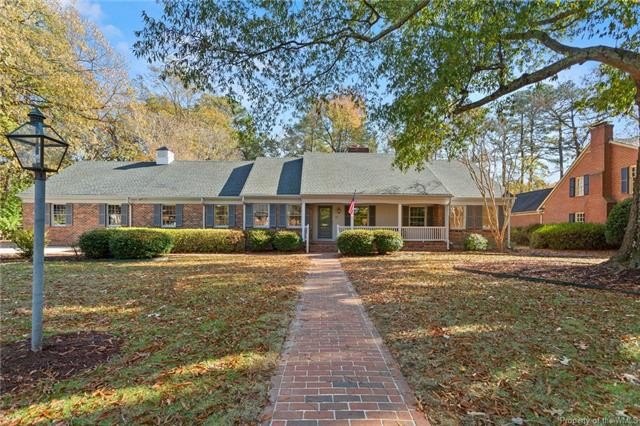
[531,223,609,250]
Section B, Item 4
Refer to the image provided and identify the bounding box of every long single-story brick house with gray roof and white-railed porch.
[21,147,508,250]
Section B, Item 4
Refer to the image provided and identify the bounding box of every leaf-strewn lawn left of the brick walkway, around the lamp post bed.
[0,255,307,424]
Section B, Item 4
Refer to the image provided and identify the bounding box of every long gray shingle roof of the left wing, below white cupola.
[18,161,252,198]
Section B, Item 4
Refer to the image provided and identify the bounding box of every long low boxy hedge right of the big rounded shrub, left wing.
[162,229,245,253]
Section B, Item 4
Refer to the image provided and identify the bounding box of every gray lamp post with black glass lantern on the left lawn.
[6,108,69,352]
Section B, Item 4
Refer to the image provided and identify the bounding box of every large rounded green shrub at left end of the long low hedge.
[109,228,173,259]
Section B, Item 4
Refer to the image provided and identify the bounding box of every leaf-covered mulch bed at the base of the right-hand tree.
[456,258,640,294]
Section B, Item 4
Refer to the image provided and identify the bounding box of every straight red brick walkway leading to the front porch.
[263,254,429,426]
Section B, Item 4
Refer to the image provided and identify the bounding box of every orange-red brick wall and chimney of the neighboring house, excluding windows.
[540,124,638,224]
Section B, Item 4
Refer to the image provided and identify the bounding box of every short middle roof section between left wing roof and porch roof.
[242,157,302,196]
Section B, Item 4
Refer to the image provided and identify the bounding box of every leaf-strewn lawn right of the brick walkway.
[342,253,640,425]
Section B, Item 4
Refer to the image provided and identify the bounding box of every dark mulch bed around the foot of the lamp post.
[0,331,120,394]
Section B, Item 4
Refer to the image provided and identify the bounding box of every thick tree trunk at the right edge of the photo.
[614,80,640,268]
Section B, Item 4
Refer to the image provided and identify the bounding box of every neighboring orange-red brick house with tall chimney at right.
[511,123,638,226]
